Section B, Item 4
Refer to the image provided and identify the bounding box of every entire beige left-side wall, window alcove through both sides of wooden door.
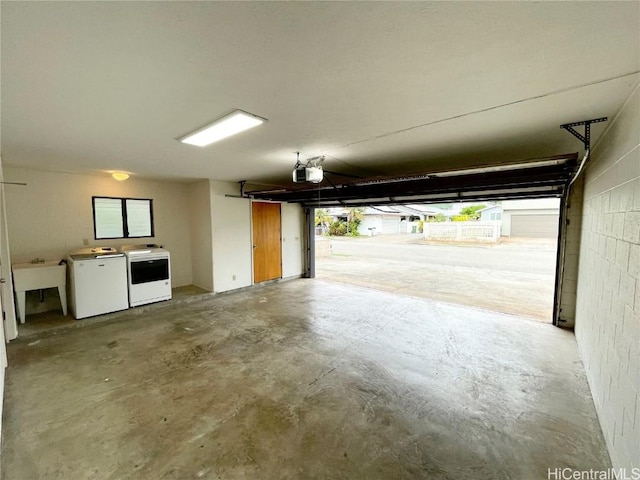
[5,167,304,313]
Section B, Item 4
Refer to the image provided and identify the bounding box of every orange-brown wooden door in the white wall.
[251,202,282,283]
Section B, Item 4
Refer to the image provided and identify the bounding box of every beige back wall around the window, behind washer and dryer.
[4,166,192,313]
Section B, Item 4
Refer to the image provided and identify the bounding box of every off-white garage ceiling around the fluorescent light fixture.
[1,2,640,185]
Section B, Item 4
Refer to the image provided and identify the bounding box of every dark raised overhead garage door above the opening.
[248,153,578,207]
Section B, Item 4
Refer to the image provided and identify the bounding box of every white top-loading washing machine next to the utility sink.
[67,247,129,320]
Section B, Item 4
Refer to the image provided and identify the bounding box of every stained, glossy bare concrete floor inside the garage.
[2,279,610,479]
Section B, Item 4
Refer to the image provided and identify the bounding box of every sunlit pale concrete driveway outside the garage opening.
[316,234,556,322]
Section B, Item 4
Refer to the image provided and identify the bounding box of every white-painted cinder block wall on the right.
[575,83,640,468]
